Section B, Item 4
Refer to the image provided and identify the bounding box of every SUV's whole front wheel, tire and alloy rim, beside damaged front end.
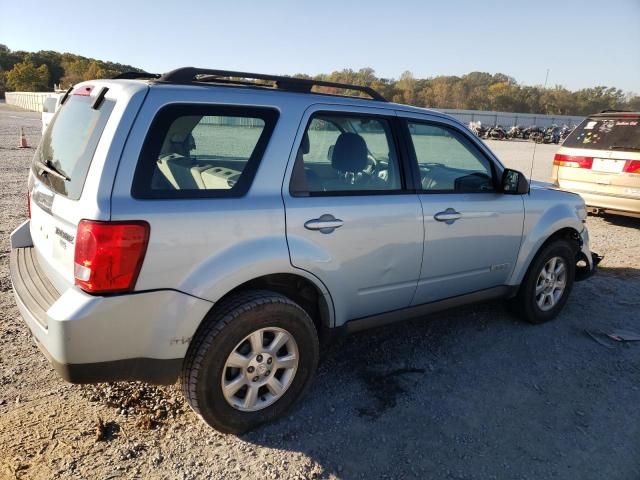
[509,239,576,324]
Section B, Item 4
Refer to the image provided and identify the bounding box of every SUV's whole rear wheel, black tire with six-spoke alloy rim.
[182,291,319,434]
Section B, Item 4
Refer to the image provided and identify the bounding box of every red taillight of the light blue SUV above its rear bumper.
[74,220,149,293]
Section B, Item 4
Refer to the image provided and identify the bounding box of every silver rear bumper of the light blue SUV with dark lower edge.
[10,223,212,384]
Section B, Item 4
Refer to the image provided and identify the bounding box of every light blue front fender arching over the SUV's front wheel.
[508,201,589,285]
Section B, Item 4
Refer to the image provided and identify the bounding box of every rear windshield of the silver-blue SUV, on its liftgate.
[32,95,115,200]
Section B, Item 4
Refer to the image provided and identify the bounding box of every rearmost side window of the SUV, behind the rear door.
[133,105,276,198]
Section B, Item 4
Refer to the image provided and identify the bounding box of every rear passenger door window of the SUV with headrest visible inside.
[291,114,401,195]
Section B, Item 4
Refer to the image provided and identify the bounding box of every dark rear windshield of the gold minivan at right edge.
[563,116,640,150]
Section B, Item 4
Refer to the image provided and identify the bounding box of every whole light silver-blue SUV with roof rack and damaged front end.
[11,68,598,432]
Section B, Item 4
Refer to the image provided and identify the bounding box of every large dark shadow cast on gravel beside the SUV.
[242,288,640,479]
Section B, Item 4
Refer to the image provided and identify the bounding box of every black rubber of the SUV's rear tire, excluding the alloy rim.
[182,290,319,434]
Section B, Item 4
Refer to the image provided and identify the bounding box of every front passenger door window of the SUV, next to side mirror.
[408,122,493,193]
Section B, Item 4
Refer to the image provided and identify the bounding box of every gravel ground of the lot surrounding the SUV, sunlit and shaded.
[0,104,640,480]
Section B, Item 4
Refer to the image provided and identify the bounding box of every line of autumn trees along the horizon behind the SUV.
[0,45,640,115]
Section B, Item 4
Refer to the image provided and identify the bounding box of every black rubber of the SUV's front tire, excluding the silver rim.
[510,239,576,324]
